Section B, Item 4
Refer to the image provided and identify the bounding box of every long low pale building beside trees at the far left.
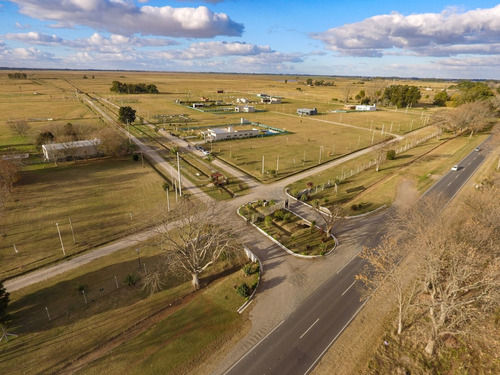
[42,138,101,161]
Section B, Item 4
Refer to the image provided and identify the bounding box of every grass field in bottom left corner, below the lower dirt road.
[0,235,254,374]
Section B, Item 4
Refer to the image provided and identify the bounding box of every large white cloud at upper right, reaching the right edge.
[313,4,500,57]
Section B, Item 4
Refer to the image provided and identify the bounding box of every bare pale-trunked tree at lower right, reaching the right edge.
[422,236,500,355]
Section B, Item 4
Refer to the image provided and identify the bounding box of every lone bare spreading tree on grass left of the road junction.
[151,199,237,289]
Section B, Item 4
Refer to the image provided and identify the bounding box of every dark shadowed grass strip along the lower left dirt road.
[8,255,241,339]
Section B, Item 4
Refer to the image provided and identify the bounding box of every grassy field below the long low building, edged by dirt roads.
[0,158,169,279]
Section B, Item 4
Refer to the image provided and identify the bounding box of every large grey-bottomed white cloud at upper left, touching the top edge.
[11,0,244,38]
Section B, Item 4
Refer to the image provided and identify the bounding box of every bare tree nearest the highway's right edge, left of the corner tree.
[356,236,417,335]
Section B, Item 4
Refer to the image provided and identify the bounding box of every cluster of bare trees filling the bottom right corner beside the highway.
[357,186,500,373]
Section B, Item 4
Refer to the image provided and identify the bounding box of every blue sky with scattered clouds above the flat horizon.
[0,0,500,79]
